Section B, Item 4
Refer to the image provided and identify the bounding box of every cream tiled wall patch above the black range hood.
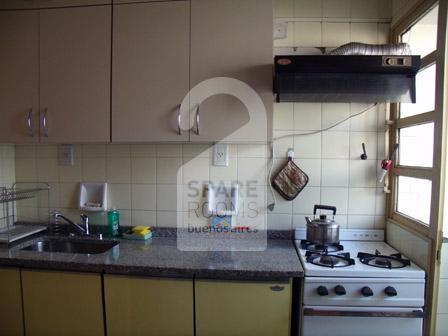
[274,0,392,48]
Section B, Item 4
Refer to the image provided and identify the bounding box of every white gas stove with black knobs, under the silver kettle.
[295,229,425,336]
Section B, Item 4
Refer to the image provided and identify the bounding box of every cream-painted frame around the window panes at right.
[386,0,448,335]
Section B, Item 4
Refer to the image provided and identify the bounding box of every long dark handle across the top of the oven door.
[303,308,425,318]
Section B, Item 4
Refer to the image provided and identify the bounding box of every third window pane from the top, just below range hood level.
[398,123,434,167]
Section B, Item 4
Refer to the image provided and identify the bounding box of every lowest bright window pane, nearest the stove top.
[397,176,431,224]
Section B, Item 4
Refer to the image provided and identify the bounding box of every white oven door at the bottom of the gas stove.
[302,306,424,336]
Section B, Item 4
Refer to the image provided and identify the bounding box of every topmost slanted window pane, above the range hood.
[401,6,439,57]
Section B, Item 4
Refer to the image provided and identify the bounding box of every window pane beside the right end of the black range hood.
[400,64,436,118]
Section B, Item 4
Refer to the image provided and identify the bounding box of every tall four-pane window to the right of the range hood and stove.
[390,4,438,232]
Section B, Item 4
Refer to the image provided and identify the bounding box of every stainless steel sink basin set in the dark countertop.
[22,237,119,254]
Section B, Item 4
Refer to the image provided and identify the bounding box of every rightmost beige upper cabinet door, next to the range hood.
[190,0,273,141]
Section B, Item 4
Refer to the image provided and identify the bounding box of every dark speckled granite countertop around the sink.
[0,236,303,280]
